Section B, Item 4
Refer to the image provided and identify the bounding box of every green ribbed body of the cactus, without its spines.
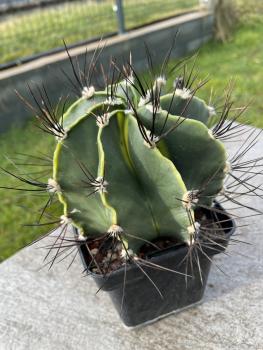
[53,72,229,253]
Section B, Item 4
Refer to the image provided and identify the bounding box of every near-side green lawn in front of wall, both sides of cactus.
[0,6,263,261]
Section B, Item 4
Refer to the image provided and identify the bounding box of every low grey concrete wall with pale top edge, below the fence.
[0,11,213,132]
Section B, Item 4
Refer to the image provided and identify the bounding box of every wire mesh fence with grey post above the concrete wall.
[0,0,199,69]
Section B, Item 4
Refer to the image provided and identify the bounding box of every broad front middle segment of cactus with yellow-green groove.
[101,113,193,251]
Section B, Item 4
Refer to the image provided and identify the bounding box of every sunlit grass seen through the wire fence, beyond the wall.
[0,0,197,64]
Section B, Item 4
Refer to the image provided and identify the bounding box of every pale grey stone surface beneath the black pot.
[0,126,263,350]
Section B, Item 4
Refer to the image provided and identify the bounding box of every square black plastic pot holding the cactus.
[80,203,235,327]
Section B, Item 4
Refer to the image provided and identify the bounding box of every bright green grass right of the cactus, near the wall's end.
[194,17,263,128]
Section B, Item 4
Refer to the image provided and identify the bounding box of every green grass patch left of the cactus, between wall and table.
[0,123,60,261]
